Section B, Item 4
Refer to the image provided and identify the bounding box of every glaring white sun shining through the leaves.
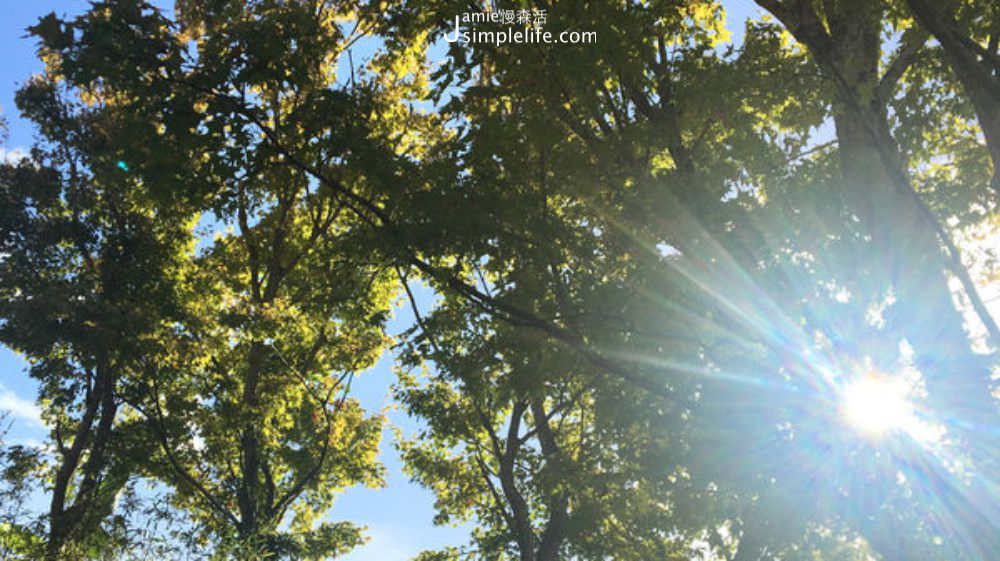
[842,376,920,437]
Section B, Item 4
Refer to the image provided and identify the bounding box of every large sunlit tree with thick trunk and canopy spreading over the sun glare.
[380,3,994,558]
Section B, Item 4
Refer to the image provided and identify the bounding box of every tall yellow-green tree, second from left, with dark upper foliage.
[14,2,426,559]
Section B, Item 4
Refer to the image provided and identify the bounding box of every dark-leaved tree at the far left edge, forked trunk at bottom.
[0,75,190,558]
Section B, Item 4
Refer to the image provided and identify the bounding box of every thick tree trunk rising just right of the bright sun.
[759,1,1000,558]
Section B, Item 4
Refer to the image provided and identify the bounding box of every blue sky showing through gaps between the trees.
[0,0,757,561]
